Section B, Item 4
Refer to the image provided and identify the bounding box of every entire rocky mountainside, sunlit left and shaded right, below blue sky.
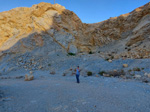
[0,2,150,58]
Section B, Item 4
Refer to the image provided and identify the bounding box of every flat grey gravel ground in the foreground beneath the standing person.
[0,72,150,112]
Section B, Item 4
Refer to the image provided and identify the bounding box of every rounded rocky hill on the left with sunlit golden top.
[0,3,82,55]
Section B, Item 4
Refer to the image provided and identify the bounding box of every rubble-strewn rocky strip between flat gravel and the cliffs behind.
[0,53,150,83]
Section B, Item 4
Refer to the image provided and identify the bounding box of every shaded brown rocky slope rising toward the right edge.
[85,3,150,58]
